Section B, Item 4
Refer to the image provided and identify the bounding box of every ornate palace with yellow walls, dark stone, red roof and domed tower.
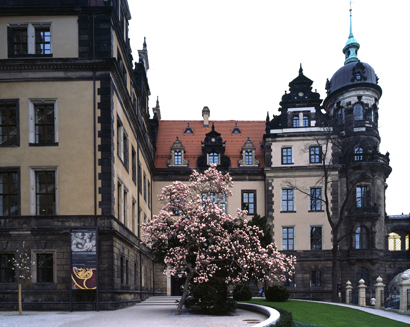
[0,0,410,310]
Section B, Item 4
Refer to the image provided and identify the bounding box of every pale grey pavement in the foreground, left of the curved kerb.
[0,305,267,327]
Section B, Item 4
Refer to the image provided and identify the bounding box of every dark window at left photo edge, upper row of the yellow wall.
[0,100,20,146]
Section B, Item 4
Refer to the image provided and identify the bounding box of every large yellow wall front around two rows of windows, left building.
[0,81,94,215]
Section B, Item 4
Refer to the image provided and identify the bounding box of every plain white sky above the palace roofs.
[128,0,410,215]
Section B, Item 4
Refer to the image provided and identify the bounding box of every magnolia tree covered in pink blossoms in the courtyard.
[143,165,296,315]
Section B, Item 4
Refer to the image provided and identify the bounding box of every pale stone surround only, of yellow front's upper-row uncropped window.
[28,98,59,146]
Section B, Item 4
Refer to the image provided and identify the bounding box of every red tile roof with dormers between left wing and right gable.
[155,120,265,168]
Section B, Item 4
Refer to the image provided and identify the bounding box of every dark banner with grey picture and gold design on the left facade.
[70,228,98,290]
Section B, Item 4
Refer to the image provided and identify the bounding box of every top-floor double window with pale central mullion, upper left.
[7,23,52,57]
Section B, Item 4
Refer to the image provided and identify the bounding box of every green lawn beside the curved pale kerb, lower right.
[249,299,409,327]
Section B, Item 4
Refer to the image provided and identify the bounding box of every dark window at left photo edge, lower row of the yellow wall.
[0,171,20,216]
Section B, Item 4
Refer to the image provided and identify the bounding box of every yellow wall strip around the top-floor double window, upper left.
[0,16,78,59]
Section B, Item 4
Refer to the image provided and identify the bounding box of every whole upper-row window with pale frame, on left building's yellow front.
[29,99,58,145]
